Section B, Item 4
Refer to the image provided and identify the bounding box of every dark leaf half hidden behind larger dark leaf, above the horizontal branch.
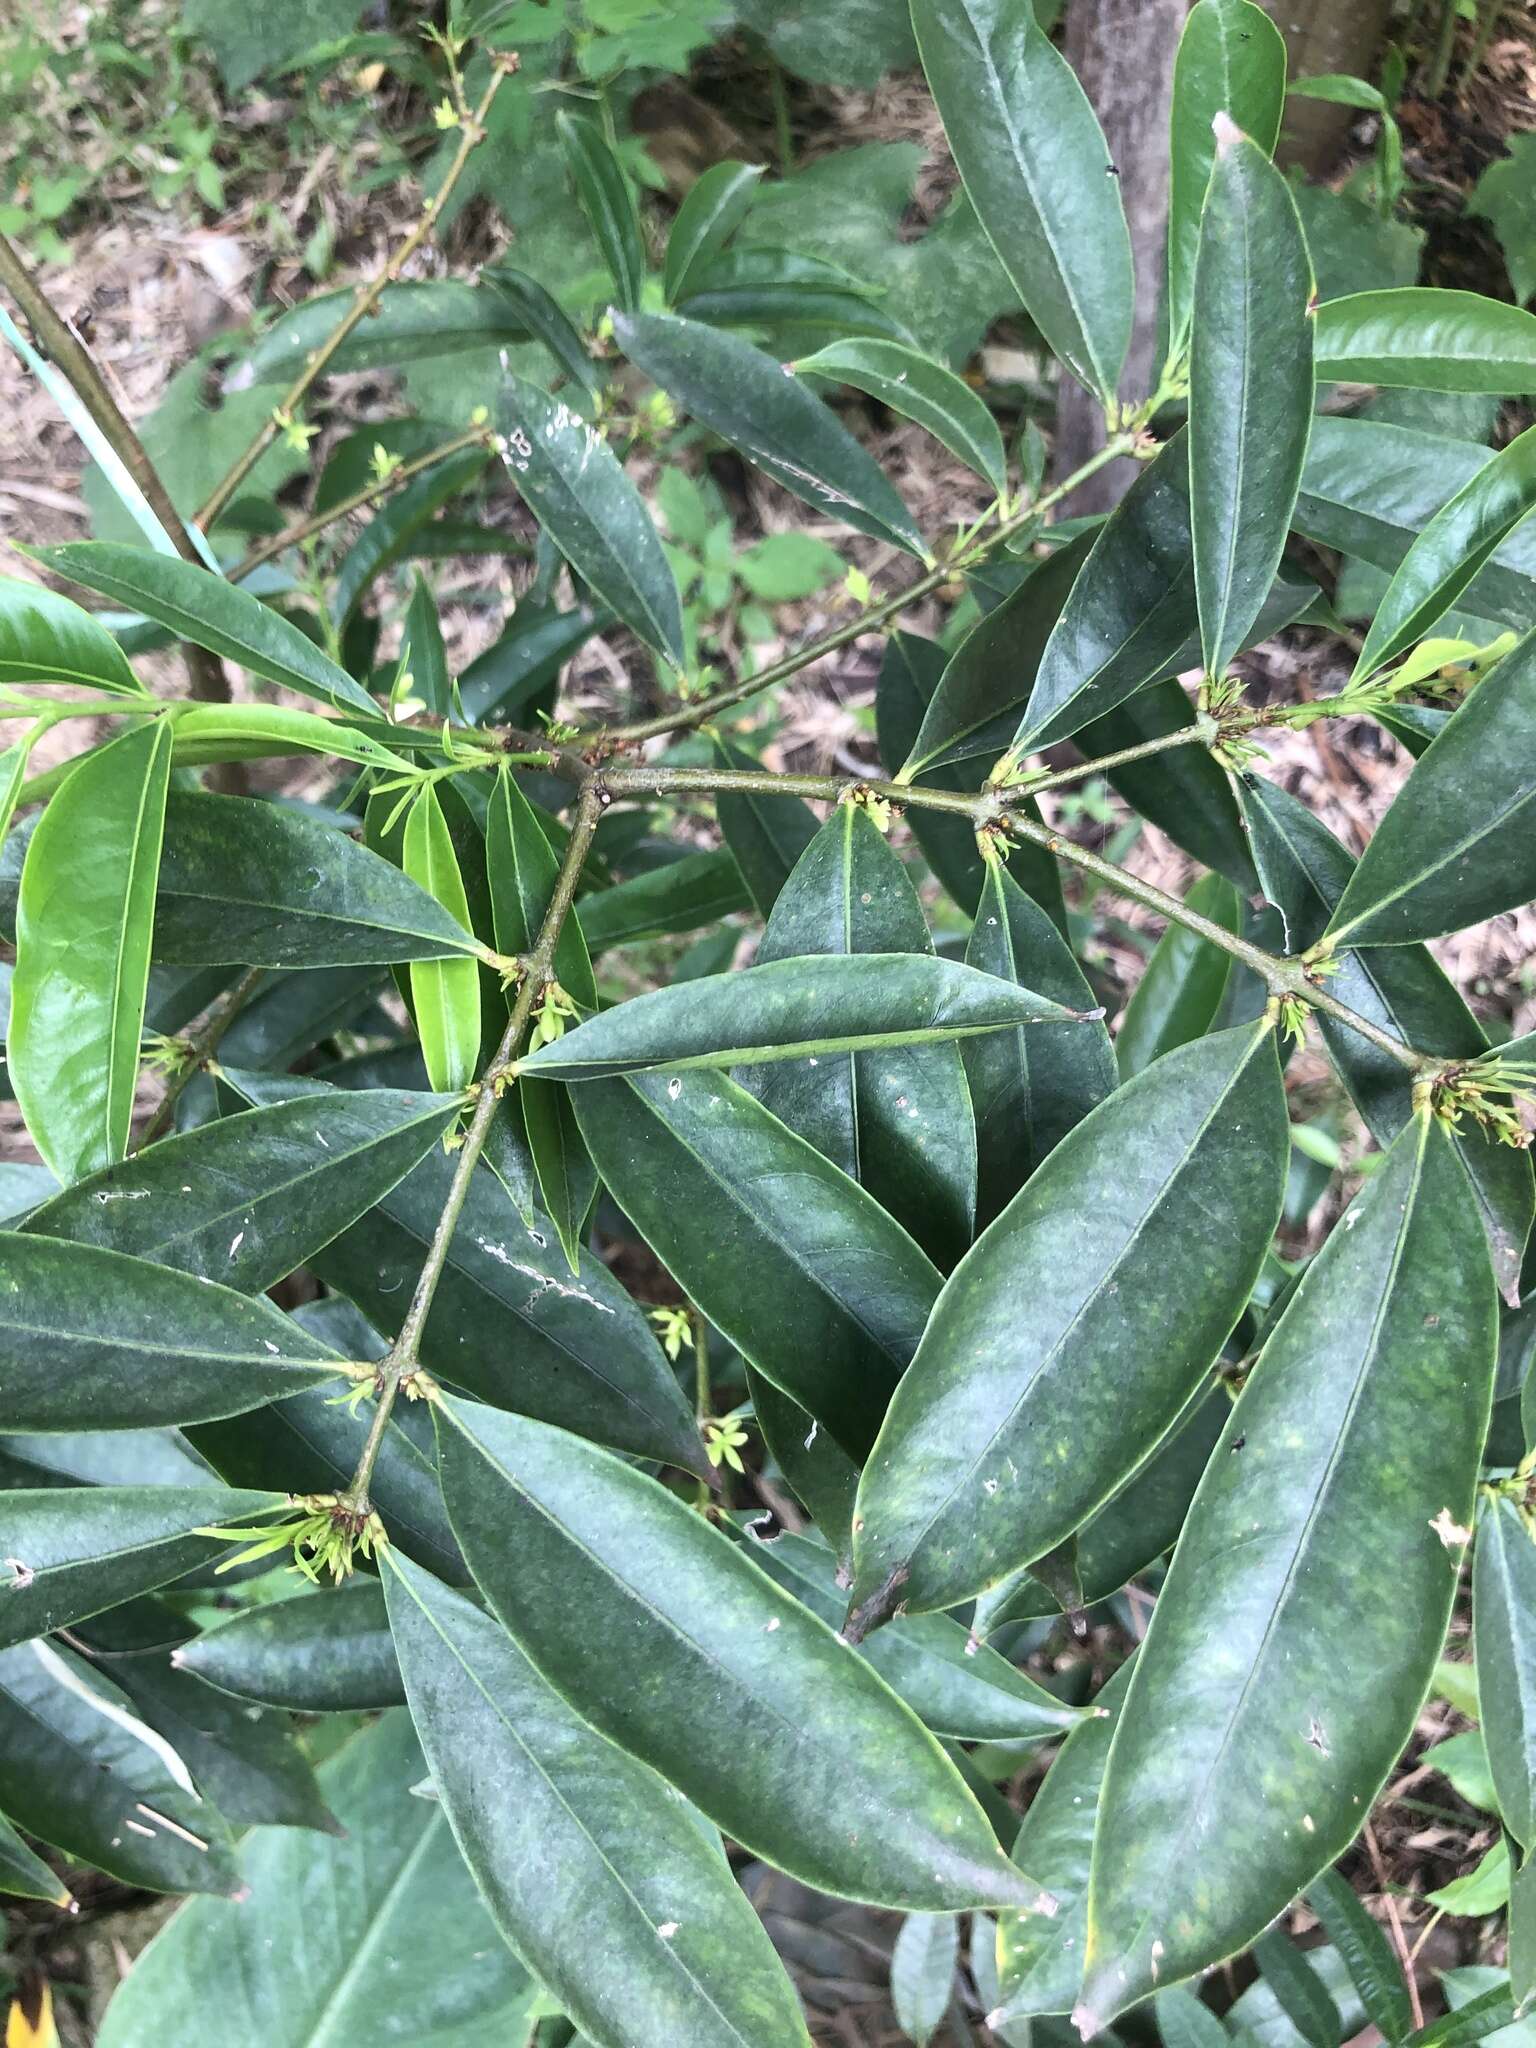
[901,535,1094,782]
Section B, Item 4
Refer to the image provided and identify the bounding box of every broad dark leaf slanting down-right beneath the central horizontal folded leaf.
[573,1073,938,1458]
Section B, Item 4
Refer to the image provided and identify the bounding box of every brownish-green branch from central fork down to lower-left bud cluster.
[344,782,604,1516]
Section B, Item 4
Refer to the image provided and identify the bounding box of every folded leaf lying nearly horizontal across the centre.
[518,946,1075,1081]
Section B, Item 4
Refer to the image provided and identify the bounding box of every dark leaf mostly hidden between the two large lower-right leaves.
[978,1391,1231,1640]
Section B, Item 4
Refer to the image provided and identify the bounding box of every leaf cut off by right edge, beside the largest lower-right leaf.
[1482,1497,1536,1849]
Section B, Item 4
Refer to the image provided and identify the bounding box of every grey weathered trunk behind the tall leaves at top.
[1055,0,1188,514]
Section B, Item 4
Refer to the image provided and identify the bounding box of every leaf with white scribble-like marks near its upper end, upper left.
[498,375,684,668]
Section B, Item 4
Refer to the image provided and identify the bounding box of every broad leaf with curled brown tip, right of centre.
[852,1026,1288,1626]
